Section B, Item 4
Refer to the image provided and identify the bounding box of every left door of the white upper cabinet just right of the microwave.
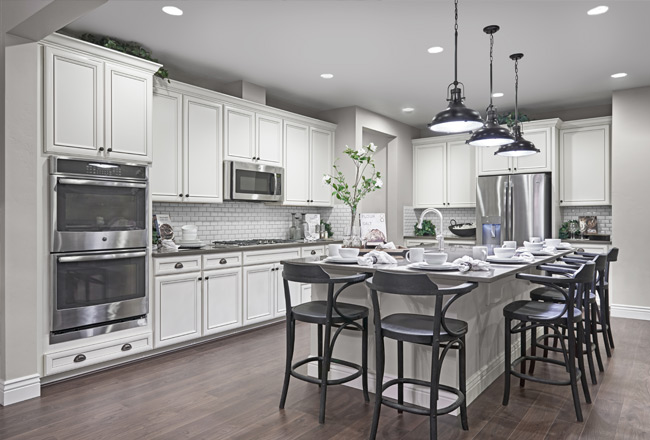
[284,122,310,205]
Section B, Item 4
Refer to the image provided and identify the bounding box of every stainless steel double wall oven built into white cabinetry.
[49,157,151,343]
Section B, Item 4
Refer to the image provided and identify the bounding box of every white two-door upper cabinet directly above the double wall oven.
[41,34,160,162]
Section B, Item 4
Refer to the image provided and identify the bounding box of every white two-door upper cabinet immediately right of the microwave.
[284,121,334,206]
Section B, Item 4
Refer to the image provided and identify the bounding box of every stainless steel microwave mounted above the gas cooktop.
[223,160,284,202]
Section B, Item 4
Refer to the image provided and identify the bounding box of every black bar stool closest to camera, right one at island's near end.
[366,270,478,440]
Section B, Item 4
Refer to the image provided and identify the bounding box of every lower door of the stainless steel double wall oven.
[51,249,149,331]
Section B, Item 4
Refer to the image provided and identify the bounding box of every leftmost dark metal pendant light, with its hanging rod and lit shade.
[428,0,483,133]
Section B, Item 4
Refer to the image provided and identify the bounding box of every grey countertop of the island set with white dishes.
[283,250,573,283]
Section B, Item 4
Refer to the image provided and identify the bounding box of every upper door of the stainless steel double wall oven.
[50,175,148,252]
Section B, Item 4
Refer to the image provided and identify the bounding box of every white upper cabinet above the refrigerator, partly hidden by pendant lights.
[476,119,561,176]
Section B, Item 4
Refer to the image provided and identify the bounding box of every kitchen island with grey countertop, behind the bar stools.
[286,251,572,407]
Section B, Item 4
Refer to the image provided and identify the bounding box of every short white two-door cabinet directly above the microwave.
[224,106,282,166]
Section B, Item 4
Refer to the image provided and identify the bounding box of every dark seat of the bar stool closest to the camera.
[381,313,467,344]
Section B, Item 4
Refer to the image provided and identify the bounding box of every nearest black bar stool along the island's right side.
[503,263,595,422]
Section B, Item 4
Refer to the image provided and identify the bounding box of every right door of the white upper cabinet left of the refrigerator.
[446,141,476,208]
